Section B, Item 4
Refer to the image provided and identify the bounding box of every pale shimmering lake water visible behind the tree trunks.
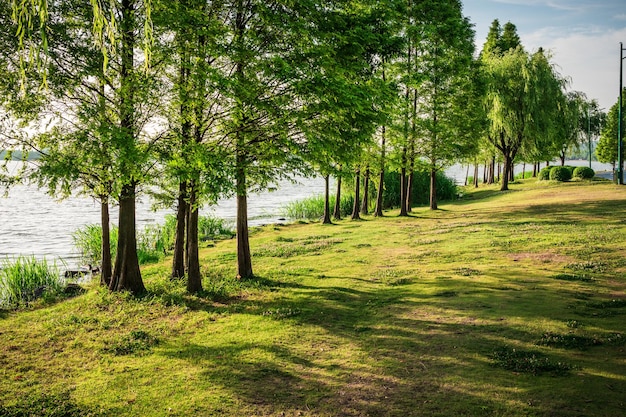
[0,161,611,267]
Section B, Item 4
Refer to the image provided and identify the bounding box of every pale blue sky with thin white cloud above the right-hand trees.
[462,0,626,112]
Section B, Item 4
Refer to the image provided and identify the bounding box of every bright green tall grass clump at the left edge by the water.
[0,256,62,308]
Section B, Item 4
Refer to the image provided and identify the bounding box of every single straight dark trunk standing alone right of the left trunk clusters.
[237,158,253,279]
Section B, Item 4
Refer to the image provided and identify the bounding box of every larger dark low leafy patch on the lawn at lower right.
[491,346,573,375]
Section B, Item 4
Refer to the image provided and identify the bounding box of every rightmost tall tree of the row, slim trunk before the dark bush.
[407,0,484,210]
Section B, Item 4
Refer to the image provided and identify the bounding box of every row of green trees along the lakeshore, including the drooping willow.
[0,0,602,292]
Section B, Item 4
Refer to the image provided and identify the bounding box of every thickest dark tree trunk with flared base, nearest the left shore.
[109,184,146,294]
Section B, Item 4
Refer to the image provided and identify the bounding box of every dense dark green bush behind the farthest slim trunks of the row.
[372,171,458,209]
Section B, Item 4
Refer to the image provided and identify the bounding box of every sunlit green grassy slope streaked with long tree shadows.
[0,181,626,416]
